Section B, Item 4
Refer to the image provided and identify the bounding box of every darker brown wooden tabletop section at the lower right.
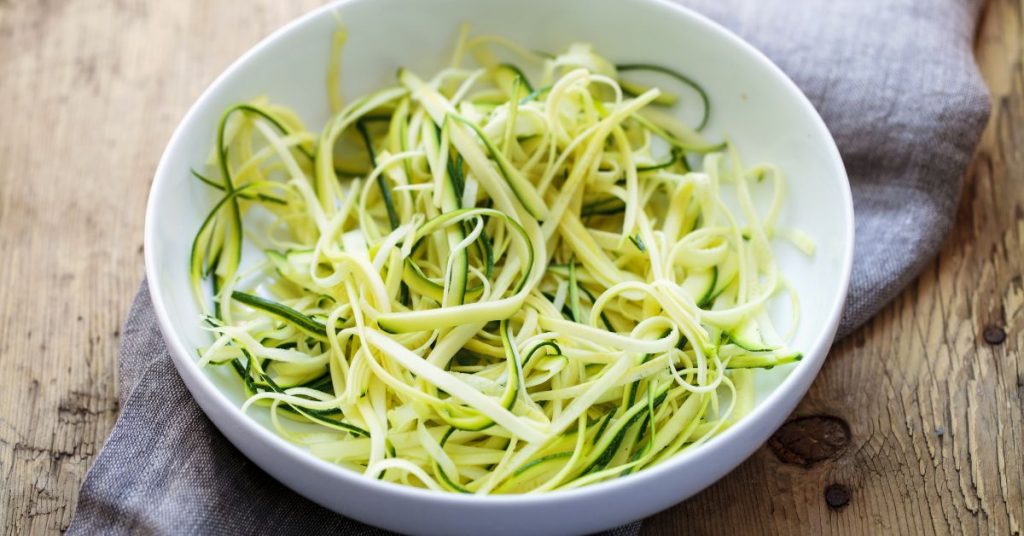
[644,0,1024,534]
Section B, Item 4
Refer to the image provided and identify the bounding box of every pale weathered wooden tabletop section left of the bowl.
[0,0,321,534]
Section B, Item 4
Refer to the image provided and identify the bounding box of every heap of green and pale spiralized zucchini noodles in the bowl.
[189,30,814,494]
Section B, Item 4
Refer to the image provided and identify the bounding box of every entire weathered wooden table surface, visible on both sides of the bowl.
[0,0,1024,534]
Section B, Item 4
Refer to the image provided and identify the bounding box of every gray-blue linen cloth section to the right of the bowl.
[682,0,989,337]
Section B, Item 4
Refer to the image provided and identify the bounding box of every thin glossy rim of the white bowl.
[143,0,854,507]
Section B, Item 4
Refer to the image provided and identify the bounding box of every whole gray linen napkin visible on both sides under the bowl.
[69,0,989,535]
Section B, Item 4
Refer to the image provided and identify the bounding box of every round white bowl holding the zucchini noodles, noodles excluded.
[145,0,853,535]
